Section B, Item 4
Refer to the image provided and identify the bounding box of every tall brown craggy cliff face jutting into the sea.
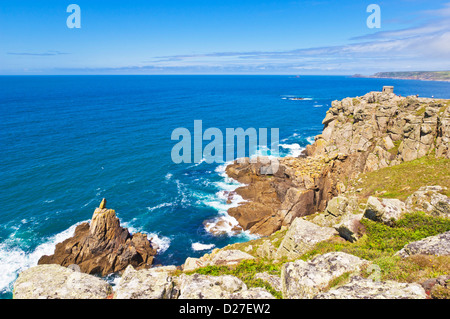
[227,92,450,235]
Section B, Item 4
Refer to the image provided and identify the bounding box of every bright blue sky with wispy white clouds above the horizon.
[0,0,450,75]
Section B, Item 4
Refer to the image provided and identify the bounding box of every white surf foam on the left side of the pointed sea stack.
[0,222,83,292]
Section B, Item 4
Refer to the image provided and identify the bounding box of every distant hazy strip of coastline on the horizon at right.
[353,71,450,82]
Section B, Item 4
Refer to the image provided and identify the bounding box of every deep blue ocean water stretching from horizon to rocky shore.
[0,76,450,298]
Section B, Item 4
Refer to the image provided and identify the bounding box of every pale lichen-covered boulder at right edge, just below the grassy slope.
[405,185,450,218]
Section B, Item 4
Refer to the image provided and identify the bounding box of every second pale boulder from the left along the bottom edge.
[114,265,176,299]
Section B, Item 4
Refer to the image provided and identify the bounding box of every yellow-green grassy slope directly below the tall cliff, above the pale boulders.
[354,156,450,200]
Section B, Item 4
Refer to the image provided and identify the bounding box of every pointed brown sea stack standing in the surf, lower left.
[38,201,157,276]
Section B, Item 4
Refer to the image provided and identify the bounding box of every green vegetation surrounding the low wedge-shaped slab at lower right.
[301,212,450,285]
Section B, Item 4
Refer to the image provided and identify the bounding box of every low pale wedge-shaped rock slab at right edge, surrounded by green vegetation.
[396,231,450,257]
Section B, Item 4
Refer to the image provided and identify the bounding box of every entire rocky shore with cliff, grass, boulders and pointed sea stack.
[14,88,450,299]
